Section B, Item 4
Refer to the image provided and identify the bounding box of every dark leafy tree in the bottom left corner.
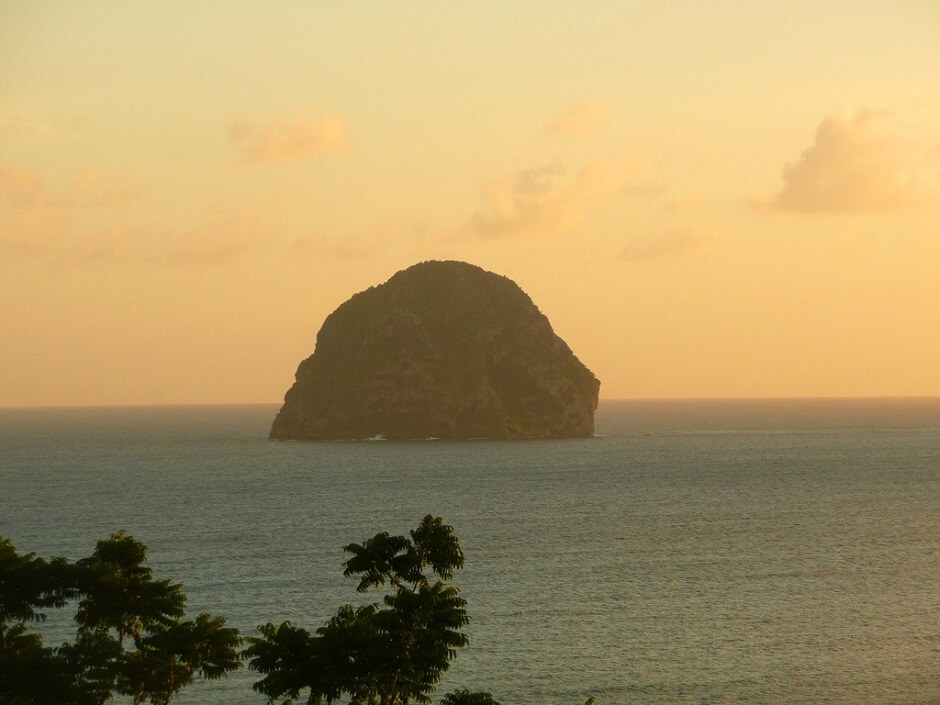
[0,532,241,705]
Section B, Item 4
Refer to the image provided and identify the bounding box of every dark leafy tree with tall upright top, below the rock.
[245,515,498,705]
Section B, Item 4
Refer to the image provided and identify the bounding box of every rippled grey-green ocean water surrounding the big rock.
[0,399,940,705]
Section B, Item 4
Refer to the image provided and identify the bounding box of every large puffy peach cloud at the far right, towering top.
[762,110,936,213]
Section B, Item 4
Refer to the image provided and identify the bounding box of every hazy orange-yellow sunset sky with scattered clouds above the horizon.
[0,0,940,406]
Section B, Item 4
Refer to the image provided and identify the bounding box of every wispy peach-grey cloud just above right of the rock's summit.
[470,160,660,238]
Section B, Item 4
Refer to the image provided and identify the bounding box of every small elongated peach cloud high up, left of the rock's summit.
[229,113,349,164]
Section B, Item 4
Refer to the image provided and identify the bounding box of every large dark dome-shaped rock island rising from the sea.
[271,262,600,440]
